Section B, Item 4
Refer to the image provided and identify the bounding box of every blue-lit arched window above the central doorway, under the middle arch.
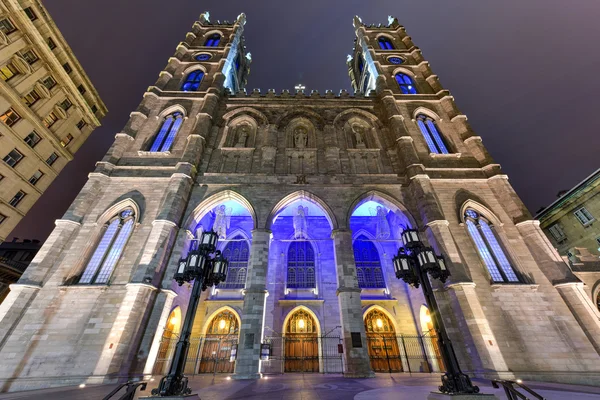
[286,240,316,289]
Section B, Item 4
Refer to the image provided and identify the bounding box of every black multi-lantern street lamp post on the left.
[152,230,228,397]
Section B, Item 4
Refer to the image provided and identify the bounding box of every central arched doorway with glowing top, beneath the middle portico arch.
[284,309,319,372]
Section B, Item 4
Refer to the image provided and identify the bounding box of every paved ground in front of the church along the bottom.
[0,374,600,400]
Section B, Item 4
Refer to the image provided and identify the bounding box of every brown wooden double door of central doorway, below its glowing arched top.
[284,333,319,372]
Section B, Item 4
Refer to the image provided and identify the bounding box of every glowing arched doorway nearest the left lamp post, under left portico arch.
[198,310,239,374]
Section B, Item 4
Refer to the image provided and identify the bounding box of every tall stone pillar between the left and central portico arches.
[233,229,271,379]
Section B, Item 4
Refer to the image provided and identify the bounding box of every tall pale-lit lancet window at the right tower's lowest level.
[465,209,520,283]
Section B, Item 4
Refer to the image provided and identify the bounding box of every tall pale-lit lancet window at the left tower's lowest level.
[79,208,135,284]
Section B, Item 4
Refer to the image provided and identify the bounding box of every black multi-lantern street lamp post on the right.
[394,229,479,394]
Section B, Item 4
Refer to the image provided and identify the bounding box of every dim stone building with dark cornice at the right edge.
[535,170,600,309]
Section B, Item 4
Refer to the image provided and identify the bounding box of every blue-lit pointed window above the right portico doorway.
[353,235,385,289]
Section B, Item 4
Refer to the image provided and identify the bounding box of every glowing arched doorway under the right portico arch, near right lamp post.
[365,308,402,372]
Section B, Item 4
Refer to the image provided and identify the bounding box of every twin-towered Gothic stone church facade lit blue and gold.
[0,13,600,391]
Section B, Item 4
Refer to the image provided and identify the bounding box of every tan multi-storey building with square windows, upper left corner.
[0,0,107,242]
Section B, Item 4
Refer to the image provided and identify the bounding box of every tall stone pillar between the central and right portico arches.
[331,229,375,378]
